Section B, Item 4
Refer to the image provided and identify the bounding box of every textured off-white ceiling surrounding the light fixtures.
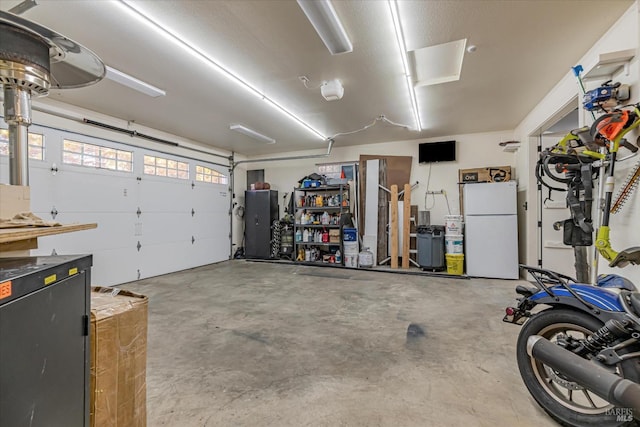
[0,0,633,155]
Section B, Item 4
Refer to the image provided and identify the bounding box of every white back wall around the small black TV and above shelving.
[240,131,518,242]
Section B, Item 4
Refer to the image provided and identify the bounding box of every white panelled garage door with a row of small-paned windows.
[0,125,230,285]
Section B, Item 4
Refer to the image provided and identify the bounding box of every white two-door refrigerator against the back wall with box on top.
[463,181,519,279]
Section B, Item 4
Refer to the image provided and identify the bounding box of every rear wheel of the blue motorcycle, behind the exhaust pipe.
[517,308,640,427]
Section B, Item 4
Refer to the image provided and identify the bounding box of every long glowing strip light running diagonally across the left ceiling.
[116,0,327,140]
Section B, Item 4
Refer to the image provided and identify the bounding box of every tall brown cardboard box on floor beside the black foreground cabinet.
[89,286,147,427]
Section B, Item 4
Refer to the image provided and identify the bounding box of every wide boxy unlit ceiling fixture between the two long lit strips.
[298,0,353,55]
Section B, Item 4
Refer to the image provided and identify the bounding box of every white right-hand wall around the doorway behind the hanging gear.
[515,1,640,283]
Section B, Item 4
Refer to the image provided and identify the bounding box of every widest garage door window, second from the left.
[62,139,133,172]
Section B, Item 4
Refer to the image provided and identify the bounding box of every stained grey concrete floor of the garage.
[122,260,556,427]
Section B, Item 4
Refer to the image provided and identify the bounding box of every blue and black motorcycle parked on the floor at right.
[503,266,640,427]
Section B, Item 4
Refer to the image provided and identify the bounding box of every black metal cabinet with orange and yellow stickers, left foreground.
[0,256,91,427]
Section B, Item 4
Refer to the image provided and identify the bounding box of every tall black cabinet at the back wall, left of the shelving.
[244,190,280,258]
